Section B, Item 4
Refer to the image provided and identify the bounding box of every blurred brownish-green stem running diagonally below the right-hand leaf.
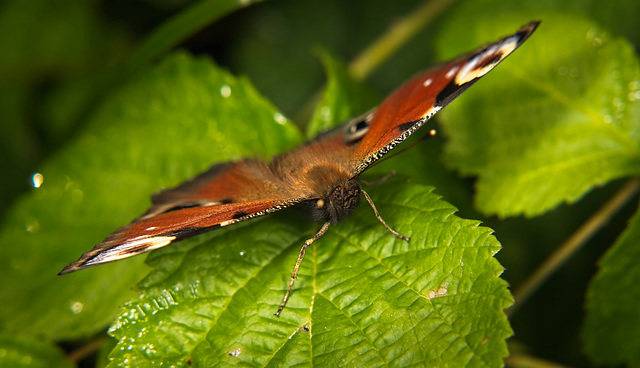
[507,179,640,316]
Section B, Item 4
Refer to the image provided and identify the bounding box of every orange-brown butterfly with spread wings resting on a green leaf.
[60,22,539,316]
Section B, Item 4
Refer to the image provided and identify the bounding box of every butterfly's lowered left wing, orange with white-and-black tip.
[60,160,307,274]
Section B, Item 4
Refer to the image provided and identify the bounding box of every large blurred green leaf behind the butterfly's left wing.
[0,51,302,339]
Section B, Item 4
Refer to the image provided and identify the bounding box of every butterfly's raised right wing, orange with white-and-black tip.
[353,22,539,176]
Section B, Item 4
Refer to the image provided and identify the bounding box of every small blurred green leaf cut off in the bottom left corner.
[0,334,74,368]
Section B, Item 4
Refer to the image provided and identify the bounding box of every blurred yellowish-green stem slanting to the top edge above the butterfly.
[349,0,456,80]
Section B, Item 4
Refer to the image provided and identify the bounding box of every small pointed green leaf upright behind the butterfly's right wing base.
[307,51,379,138]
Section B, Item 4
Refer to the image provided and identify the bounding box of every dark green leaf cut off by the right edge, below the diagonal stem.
[583,200,640,367]
